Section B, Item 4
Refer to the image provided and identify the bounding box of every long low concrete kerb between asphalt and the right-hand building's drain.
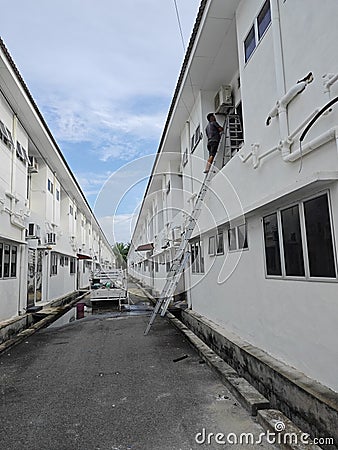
[134,281,321,450]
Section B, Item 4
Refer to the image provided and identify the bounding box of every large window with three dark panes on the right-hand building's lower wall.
[263,194,337,279]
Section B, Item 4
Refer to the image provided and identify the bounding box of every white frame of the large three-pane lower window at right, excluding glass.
[261,190,338,283]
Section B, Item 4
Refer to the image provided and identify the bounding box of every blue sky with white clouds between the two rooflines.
[0,0,200,243]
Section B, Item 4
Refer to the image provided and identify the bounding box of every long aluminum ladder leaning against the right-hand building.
[144,141,224,336]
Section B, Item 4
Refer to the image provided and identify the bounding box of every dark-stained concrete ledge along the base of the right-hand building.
[181,310,338,449]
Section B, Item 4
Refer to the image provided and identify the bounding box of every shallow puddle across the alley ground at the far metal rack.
[48,301,153,328]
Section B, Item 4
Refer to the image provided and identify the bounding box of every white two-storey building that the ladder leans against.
[129,0,338,442]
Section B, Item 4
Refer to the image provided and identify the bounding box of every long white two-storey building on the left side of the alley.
[0,40,114,322]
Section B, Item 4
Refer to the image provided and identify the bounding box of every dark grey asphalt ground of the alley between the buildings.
[0,286,275,450]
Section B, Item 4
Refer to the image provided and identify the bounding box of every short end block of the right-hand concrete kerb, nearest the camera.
[257,409,321,450]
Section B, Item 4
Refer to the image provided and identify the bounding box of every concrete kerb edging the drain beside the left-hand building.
[0,292,88,355]
